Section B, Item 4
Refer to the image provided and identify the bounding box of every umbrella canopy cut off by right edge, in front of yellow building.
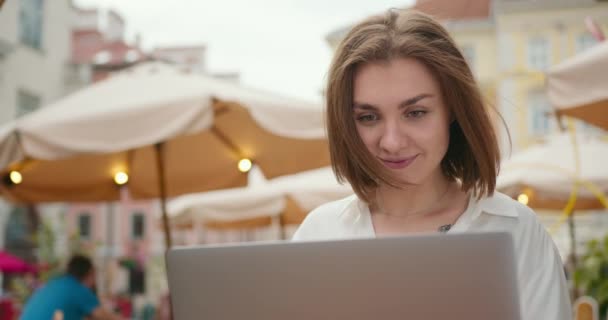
[547,41,608,130]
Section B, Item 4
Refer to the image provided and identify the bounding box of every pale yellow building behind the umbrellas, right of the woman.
[494,0,608,152]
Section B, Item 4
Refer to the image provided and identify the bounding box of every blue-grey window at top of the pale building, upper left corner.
[19,0,43,49]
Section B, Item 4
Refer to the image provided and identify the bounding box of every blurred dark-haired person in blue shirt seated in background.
[21,255,123,320]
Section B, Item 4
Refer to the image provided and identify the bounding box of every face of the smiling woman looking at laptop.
[353,58,450,184]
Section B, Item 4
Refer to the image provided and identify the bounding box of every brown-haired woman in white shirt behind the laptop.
[294,10,572,320]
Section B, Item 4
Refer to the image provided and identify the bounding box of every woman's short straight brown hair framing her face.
[326,9,500,203]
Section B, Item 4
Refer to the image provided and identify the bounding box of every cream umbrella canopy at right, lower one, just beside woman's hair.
[496,133,608,209]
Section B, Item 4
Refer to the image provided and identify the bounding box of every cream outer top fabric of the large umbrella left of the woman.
[0,62,324,167]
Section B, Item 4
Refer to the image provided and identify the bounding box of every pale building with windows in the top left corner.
[0,0,72,124]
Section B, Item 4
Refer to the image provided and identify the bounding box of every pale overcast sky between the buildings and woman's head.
[75,0,413,103]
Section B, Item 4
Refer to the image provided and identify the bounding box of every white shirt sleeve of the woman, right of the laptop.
[518,210,573,320]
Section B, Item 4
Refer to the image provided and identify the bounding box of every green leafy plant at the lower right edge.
[574,235,608,319]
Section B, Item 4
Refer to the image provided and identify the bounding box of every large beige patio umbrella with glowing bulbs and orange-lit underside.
[0,63,329,247]
